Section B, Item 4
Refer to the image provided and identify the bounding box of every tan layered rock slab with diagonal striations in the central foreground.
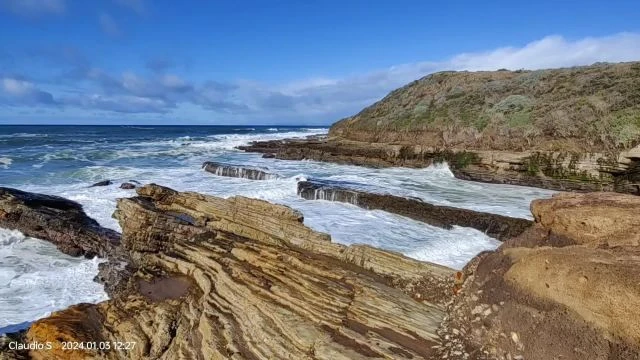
[27,185,455,359]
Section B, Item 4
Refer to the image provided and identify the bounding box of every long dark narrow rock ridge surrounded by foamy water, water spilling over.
[298,180,532,241]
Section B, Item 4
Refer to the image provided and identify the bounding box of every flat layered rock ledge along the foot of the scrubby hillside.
[238,137,640,195]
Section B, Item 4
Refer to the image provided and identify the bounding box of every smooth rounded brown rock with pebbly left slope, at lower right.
[438,193,640,360]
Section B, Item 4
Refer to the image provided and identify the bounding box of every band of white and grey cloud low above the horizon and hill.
[3,33,640,122]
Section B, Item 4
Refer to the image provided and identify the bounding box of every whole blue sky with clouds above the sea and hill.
[0,0,640,125]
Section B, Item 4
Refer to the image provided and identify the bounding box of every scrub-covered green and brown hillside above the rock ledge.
[331,62,640,152]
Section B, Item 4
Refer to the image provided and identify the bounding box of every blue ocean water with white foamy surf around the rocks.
[0,126,553,333]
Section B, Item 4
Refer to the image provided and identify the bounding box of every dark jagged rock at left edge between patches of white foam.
[0,187,120,257]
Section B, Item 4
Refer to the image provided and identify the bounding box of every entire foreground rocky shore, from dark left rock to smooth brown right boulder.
[0,184,640,360]
